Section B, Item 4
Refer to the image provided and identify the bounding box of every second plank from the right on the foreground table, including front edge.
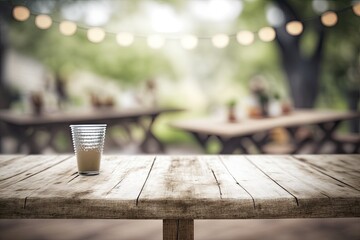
[248,156,360,217]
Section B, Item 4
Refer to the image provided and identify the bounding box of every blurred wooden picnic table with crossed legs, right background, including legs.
[171,110,360,154]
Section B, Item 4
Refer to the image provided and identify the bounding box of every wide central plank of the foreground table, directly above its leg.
[138,156,254,219]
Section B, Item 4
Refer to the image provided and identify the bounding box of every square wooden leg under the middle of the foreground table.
[163,219,194,240]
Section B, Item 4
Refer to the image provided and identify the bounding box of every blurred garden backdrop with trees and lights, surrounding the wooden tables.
[0,0,360,239]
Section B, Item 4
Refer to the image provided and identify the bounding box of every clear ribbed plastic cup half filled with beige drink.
[70,124,106,176]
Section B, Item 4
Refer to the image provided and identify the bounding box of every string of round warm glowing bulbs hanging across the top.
[12,3,360,49]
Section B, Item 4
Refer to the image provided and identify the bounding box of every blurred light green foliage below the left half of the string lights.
[10,15,177,85]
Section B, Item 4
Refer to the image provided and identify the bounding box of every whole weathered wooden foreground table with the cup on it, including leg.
[0,155,360,240]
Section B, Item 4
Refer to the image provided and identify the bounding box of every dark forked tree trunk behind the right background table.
[274,0,325,108]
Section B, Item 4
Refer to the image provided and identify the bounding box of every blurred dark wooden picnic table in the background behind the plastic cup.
[0,108,180,154]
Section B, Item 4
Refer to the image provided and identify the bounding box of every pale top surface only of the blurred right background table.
[171,109,360,137]
